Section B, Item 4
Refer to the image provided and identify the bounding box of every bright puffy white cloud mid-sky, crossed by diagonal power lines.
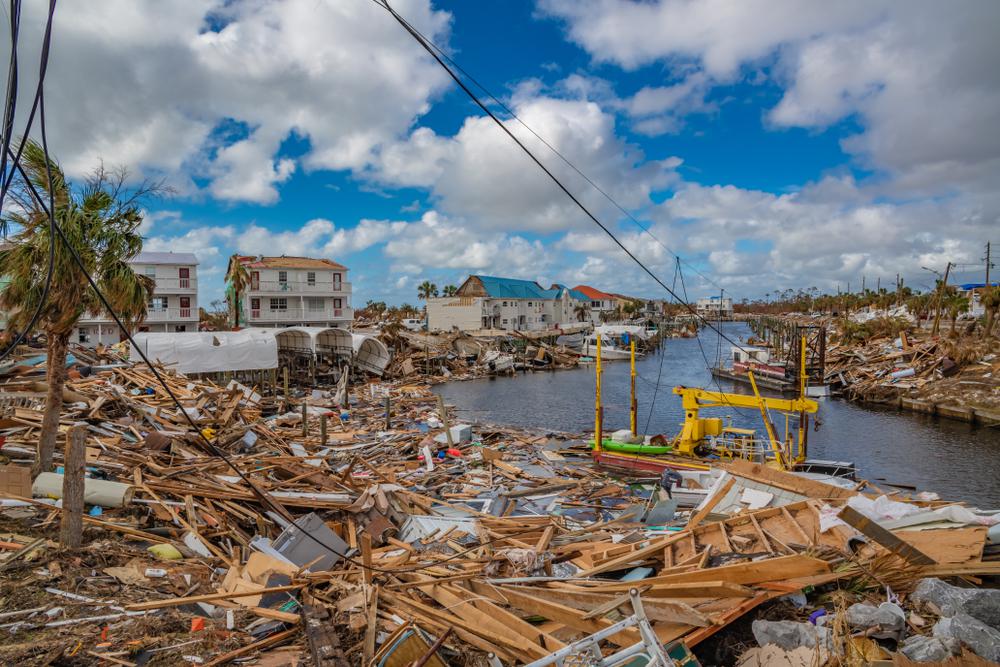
[372,87,680,232]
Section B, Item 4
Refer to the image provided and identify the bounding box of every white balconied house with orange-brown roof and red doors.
[239,255,354,329]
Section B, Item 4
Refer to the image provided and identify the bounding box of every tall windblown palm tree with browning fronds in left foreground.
[0,141,158,474]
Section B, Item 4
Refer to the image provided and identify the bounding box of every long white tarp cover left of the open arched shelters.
[129,329,278,373]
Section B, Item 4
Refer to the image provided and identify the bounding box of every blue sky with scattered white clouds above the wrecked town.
[7,0,1000,306]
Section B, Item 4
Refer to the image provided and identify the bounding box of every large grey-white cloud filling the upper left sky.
[13,0,450,203]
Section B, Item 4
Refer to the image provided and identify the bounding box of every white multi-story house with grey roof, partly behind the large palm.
[73,252,198,347]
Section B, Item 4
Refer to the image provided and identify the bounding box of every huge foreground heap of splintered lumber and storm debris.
[0,342,1000,667]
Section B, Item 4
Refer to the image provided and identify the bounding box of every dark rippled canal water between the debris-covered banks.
[434,322,1000,509]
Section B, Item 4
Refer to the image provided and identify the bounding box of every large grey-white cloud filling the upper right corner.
[540,0,1000,195]
